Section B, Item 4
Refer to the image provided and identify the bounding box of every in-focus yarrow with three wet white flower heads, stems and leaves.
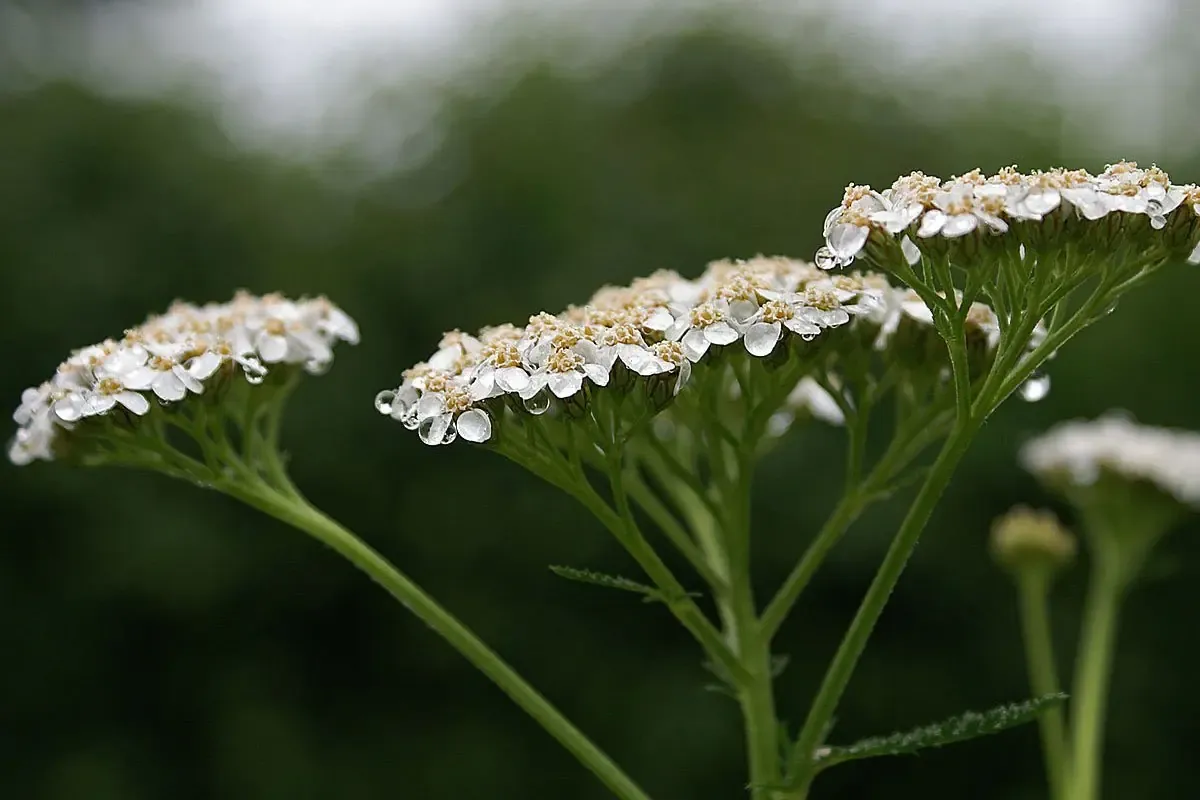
[12,163,1200,800]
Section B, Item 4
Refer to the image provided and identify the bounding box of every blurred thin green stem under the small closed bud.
[1016,569,1068,800]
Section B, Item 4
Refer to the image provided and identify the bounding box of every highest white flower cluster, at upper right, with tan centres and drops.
[817,162,1200,269]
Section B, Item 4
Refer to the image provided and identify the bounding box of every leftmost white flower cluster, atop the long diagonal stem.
[8,293,359,464]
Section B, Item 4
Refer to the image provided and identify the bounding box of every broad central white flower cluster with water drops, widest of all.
[376,255,998,445]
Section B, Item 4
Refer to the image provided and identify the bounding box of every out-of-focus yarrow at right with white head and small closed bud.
[992,414,1200,800]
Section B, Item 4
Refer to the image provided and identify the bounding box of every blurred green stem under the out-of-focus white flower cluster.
[1068,547,1124,800]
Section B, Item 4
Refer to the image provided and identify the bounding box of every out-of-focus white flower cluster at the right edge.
[1020,414,1200,507]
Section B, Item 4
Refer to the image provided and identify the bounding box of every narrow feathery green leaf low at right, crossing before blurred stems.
[817,693,1067,769]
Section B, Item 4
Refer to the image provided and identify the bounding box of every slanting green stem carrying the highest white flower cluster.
[788,419,978,796]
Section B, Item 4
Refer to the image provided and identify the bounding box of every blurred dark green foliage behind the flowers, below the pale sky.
[7,7,1200,800]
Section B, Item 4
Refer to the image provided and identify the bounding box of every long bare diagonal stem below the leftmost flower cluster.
[222,483,649,800]
